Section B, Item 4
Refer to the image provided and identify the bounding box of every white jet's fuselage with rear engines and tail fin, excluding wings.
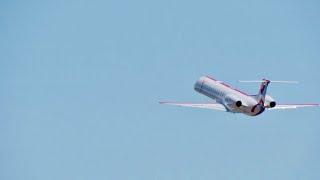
[194,76,275,116]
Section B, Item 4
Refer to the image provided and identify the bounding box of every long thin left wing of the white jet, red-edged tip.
[159,102,227,111]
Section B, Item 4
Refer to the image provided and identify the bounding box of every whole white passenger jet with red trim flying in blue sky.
[159,76,320,116]
